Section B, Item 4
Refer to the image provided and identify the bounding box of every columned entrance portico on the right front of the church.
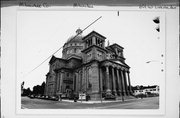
[100,61,132,96]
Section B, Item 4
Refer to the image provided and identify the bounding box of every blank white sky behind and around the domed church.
[17,10,165,89]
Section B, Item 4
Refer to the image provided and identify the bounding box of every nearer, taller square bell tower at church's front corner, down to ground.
[81,31,107,99]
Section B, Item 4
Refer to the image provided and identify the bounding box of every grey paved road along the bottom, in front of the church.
[21,97,159,109]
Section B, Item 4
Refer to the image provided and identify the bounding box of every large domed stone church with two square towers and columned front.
[45,29,132,100]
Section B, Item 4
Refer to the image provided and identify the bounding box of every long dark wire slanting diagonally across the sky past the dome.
[26,16,102,76]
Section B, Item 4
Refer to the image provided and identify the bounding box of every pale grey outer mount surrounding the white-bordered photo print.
[1,4,180,118]
